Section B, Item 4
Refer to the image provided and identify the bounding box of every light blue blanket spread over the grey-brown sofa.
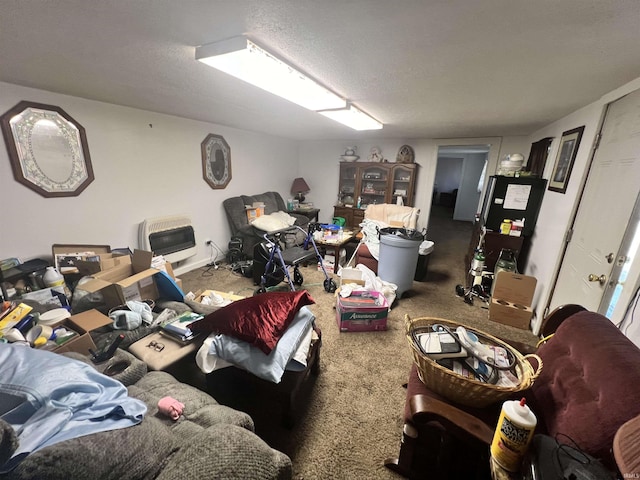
[0,344,147,473]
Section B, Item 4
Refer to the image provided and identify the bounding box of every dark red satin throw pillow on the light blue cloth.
[189,290,315,355]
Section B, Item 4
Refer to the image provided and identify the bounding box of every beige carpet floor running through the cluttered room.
[174,210,535,480]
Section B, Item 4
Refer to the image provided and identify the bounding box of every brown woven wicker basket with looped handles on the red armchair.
[405,315,542,408]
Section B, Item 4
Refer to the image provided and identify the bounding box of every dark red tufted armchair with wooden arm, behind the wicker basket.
[385,309,640,479]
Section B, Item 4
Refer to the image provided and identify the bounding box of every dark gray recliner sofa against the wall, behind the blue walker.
[222,192,309,258]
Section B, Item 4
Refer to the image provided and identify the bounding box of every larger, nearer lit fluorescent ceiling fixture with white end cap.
[196,36,347,110]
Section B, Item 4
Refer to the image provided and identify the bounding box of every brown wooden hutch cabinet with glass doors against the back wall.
[333,162,418,227]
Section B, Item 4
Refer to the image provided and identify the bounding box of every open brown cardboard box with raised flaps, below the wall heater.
[81,250,160,308]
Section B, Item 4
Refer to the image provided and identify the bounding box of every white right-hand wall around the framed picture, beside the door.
[525,78,640,331]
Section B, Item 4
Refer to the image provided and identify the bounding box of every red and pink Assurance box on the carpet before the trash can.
[336,291,389,332]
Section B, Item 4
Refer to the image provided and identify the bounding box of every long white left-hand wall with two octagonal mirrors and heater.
[0,83,300,273]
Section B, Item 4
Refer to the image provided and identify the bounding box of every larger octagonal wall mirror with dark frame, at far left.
[0,101,94,197]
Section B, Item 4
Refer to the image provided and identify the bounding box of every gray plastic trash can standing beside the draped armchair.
[378,227,424,298]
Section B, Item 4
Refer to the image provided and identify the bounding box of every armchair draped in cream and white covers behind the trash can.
[356,203,420,273]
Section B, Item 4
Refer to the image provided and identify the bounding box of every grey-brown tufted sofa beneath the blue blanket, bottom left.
[0,345,292,480]
